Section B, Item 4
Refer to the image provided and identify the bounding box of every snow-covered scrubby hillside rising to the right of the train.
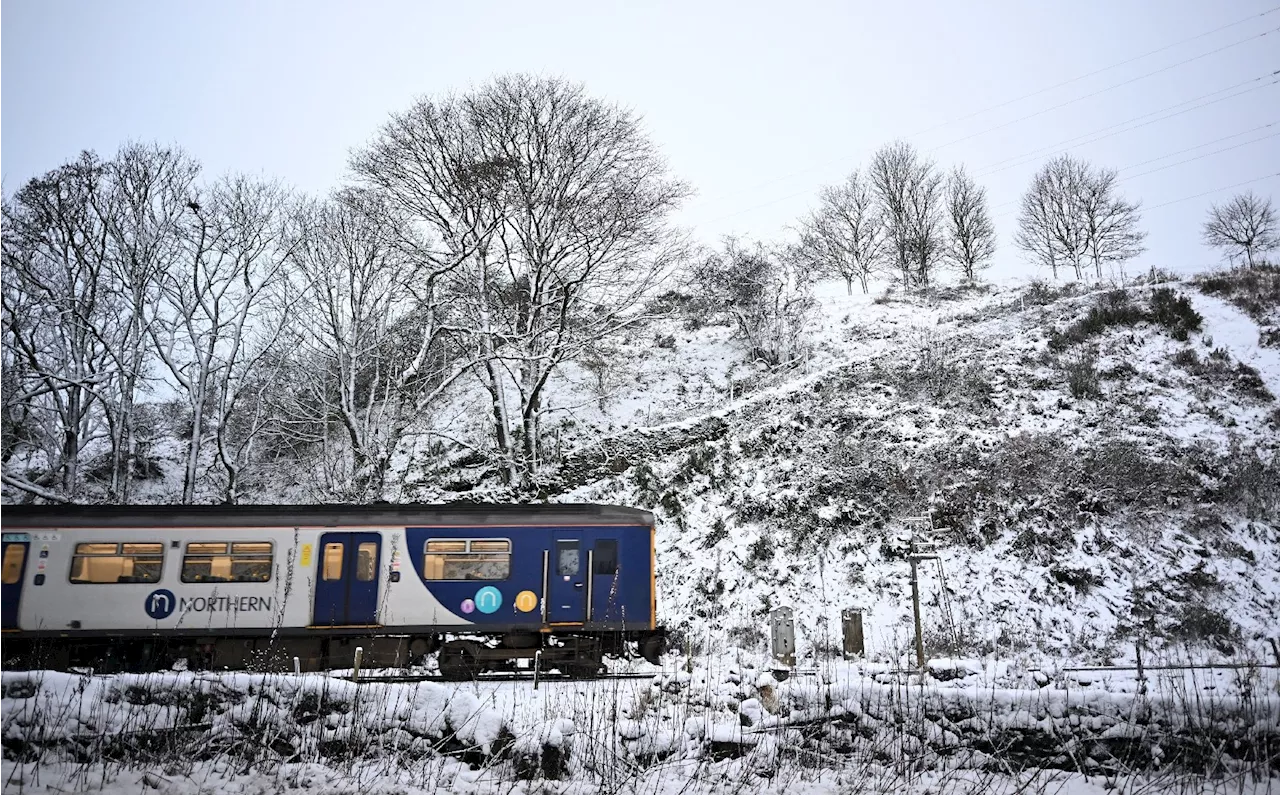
[545,272,1280,662]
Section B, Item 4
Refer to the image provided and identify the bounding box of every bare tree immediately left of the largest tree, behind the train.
[277,191,471,499]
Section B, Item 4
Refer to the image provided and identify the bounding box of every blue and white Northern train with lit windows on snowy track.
[0,503,666,680]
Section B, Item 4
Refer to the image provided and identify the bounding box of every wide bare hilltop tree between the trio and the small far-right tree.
[1015,155,1146,279]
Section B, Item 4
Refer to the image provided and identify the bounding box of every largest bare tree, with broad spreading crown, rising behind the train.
[353,76,687,483]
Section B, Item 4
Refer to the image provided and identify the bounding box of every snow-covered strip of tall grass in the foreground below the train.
[0,652,1280,792]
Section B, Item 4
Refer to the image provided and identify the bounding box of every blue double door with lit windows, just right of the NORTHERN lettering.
[312,533,383,626]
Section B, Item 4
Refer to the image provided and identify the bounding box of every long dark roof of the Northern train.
[0,503,654,529]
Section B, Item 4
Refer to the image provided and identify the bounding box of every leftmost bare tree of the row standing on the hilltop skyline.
[794,170,884,294]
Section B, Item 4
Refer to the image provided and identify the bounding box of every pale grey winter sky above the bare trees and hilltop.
[0,0,1280,280]
